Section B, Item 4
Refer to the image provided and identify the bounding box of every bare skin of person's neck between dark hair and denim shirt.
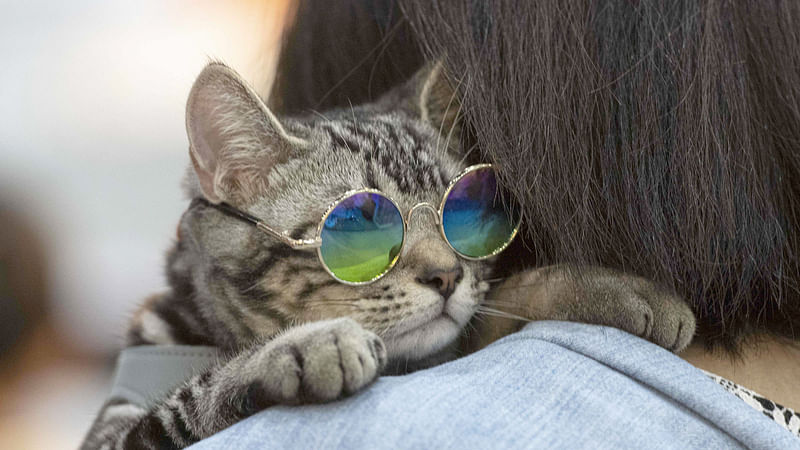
[679,336,800,411]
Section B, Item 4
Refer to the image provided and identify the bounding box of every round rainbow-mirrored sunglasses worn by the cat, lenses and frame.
[204,164,521,285]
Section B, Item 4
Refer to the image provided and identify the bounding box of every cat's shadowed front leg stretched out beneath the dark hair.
[472,266,695,352]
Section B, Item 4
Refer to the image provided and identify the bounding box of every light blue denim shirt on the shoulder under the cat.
[192,321,800,449]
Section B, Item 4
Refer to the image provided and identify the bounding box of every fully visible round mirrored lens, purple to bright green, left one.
[319,192,404,283]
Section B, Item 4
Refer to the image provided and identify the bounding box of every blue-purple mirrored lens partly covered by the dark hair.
[442,167,520,258]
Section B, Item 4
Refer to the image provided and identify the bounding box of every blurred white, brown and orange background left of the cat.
[0,0,290,449]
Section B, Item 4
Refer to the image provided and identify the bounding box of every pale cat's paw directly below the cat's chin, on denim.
[248,318,387,409]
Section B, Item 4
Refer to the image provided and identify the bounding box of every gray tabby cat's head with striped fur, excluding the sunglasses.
[180,63,489,359]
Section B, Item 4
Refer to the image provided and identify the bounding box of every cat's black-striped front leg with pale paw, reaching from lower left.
[83,319,387,449]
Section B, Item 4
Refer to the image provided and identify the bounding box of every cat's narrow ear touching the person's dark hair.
[409,62,461,141]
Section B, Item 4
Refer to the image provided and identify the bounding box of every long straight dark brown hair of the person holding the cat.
[272,0,800,350]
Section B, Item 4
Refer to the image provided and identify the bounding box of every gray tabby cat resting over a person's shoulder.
[83,63,694,448]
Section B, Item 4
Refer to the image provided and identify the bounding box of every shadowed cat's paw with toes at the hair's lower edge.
[589,275,695,353]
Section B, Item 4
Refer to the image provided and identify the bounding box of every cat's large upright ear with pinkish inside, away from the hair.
[186,63,306,204]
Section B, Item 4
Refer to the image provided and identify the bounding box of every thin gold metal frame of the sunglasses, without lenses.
[206,164,522,286]
